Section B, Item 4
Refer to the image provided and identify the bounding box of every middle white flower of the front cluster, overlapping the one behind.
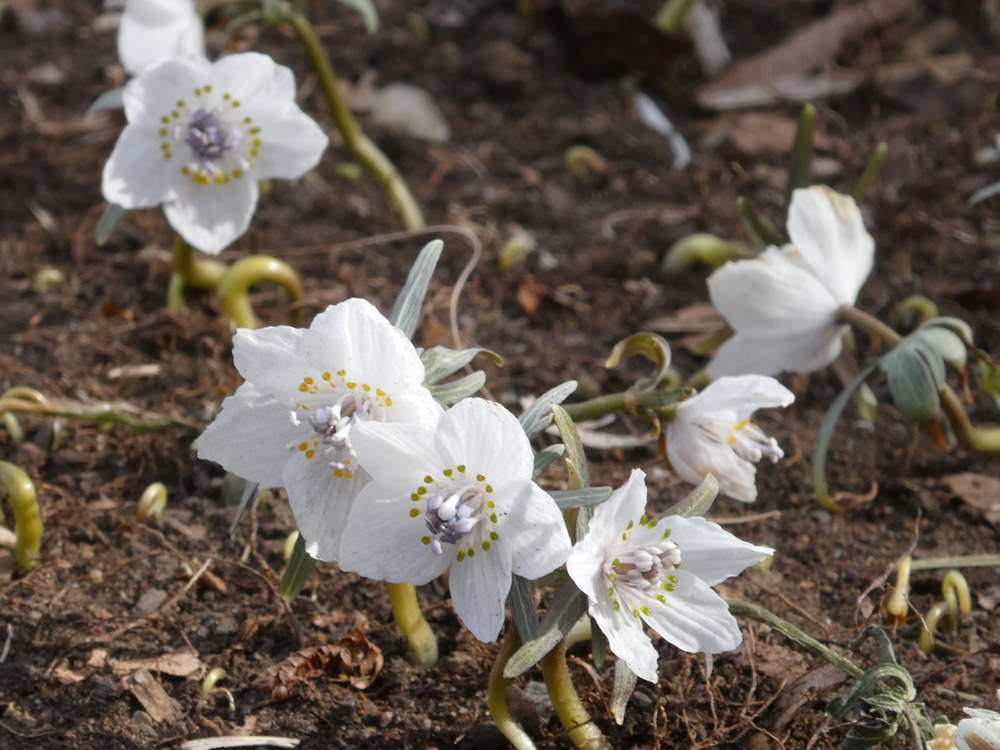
[339,398,570,641]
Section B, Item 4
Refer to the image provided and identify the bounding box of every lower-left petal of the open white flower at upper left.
[101,125,179,208]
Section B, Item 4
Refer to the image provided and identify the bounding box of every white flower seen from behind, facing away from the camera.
[708,185,875,378]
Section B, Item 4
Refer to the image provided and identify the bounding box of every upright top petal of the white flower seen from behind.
[788,185,875,305]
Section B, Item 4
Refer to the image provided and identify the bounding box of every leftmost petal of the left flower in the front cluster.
[197,383,299,487]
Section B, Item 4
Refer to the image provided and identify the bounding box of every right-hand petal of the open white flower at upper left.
[253,104,330,180]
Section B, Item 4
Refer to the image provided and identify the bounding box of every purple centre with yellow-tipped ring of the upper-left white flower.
[159,85,262,185]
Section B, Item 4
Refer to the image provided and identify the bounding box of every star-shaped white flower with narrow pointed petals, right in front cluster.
[566,469,774,682]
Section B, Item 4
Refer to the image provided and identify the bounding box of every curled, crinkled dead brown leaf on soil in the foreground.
[253,630,383,700]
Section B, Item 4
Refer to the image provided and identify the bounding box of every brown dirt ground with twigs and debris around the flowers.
[0,0,1000,750]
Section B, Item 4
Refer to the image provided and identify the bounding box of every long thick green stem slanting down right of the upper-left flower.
[287,10,424,231]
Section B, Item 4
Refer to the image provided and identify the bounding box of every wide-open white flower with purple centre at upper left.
[102,52,327,255]
